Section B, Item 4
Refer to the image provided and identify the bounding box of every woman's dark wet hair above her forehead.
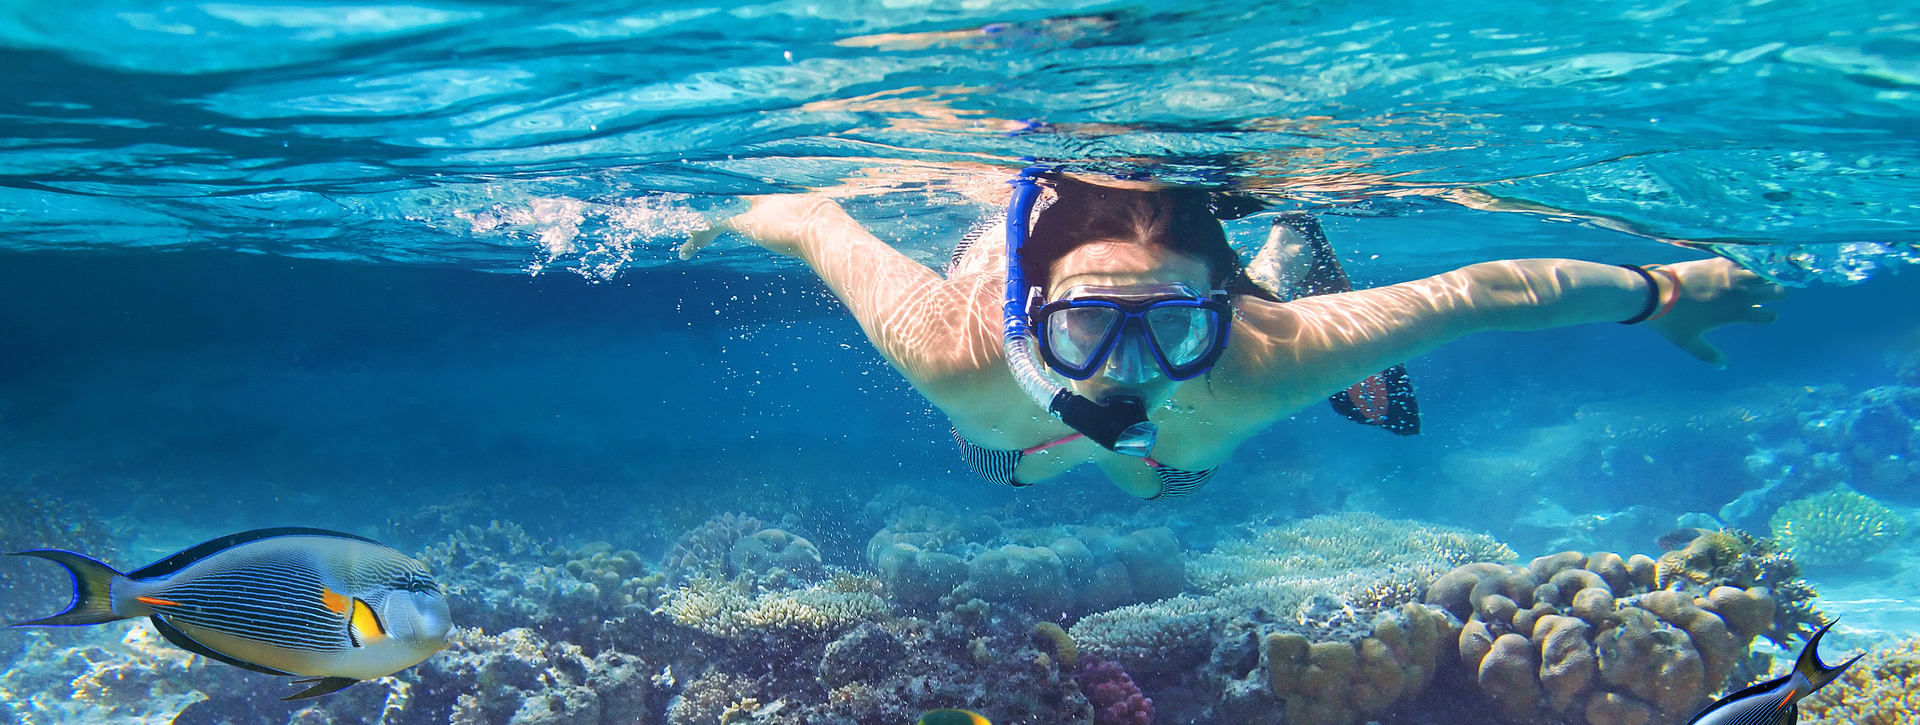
[1020,175,1271,297]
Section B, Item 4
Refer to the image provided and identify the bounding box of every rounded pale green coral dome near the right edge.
[1768,491,1907,566]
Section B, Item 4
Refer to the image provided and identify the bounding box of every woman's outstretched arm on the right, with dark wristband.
[1221,257,1786,409]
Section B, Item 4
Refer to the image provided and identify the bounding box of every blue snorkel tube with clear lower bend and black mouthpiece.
[1000,167,1160,458]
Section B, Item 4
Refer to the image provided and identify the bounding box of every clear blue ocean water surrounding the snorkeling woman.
[0,0,1920,723]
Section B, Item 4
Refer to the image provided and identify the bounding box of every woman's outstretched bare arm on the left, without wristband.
[680,194,1012,414]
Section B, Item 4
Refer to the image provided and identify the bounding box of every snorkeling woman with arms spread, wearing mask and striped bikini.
[682,171,1786,499]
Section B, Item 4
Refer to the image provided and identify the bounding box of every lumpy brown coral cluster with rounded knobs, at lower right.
[1427,544,1818,725]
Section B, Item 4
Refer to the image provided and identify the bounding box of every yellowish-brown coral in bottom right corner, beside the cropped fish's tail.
[1799,639,1920,725]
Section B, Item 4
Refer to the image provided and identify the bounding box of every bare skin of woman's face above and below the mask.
[1046,242,1212,409]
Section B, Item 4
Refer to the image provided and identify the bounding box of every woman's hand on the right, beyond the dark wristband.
[1647,257,1788,368]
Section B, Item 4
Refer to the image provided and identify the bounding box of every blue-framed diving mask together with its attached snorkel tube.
[1000,167,1233,458]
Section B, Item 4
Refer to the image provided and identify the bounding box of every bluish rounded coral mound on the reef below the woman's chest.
[866,506,1187,614]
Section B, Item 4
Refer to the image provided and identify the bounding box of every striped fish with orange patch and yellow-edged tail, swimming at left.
[13,527,453,700]
